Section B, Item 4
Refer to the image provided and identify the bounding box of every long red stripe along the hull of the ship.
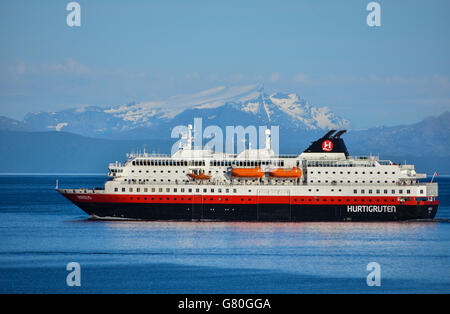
[64,193,439,205]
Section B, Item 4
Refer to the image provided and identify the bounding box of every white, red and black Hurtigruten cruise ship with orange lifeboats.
[56,125,439,222]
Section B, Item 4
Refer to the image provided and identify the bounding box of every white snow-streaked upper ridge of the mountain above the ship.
[98,84,349,129]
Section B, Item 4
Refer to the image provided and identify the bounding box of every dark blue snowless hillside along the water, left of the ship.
[0,131,171,173]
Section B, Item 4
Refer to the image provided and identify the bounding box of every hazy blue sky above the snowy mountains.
[0,0,450,128]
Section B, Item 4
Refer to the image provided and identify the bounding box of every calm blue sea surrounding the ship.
[0,175,450,293]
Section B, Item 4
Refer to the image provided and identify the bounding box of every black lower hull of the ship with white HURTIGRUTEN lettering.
[75,202,438,222]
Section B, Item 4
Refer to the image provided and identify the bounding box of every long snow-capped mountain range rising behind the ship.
[7,85,350,139]
